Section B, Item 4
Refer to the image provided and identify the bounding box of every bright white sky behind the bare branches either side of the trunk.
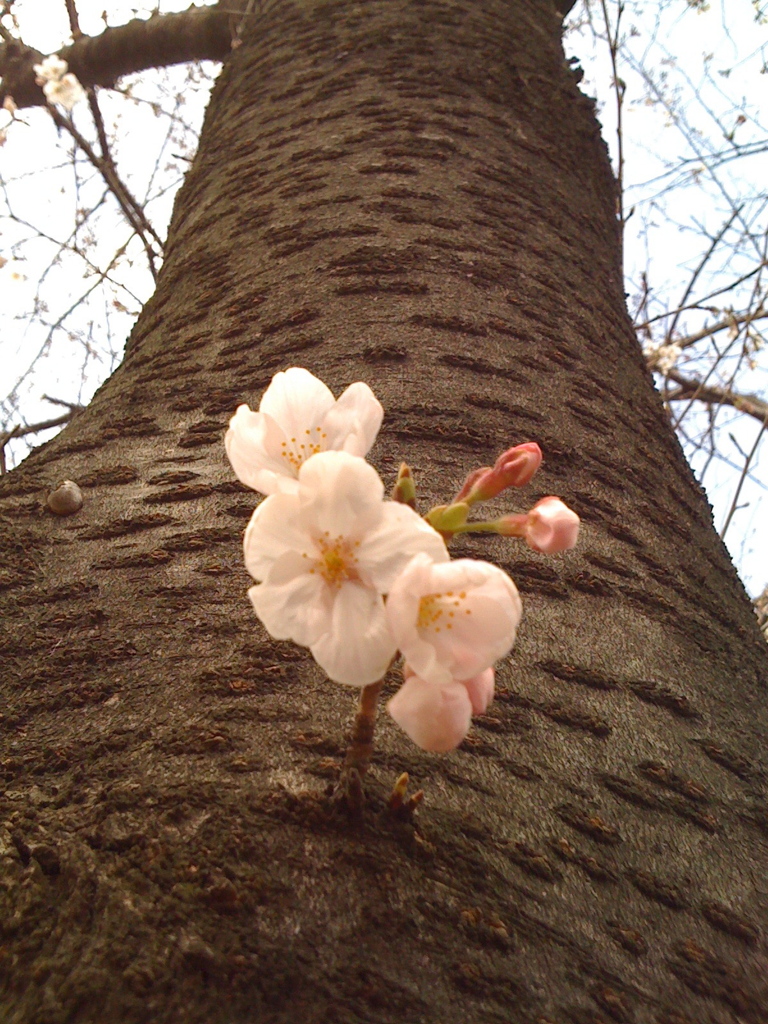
[0,0,768,593]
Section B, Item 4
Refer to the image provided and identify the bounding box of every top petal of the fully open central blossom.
[299,452,385,541]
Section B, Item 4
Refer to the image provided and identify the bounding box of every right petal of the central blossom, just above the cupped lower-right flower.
[357,502,450,594]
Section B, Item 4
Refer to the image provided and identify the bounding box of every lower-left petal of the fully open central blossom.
[248,551,333,647]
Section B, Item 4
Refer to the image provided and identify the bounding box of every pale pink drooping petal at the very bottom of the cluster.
[387,676,472,753]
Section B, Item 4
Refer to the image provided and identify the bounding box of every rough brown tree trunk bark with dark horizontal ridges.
[0,0,768,1024]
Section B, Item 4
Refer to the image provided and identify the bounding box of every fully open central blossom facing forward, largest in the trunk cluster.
[244,452,448,686]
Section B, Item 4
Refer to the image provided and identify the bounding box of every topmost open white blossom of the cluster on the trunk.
[224,367,384,495]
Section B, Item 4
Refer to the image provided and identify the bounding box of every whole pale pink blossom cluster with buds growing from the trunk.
[225,367,579,751]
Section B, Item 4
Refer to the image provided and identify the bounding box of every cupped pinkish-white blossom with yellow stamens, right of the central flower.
[387,553,522,685]
